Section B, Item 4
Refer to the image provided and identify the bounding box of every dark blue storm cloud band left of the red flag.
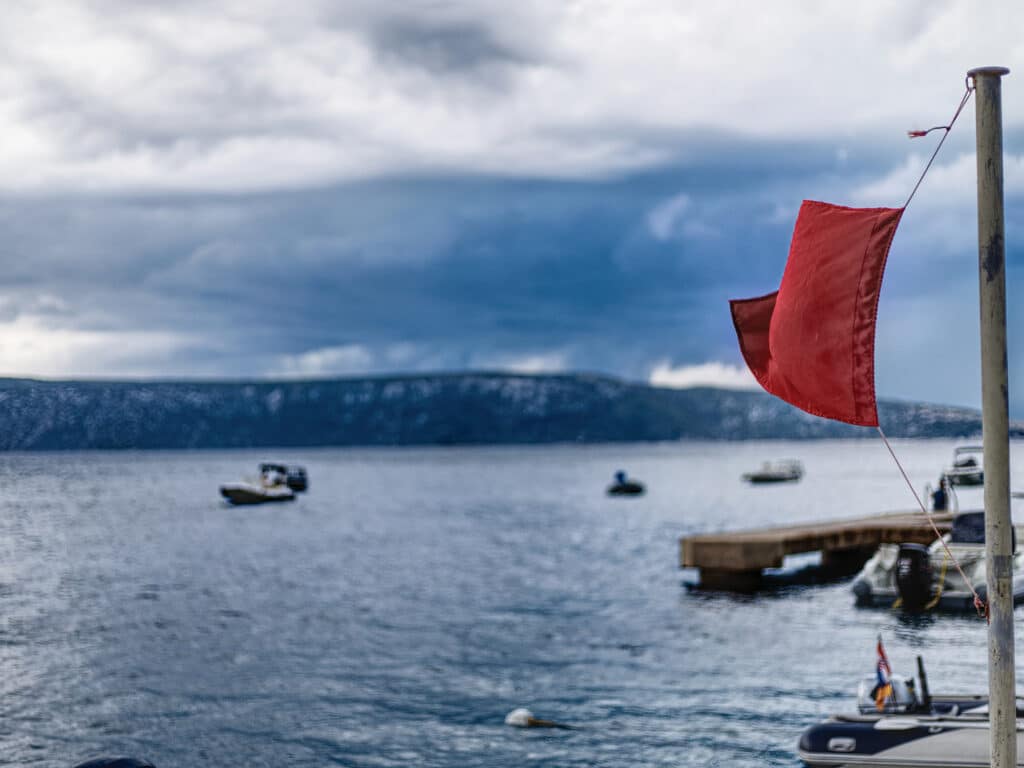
[0,134,917,378]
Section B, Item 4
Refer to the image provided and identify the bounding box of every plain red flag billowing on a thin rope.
[729,200,903,427]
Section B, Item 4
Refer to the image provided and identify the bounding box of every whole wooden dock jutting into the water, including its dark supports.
[679,512,952,592]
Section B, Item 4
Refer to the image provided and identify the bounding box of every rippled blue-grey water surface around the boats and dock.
[0,440,1024,768]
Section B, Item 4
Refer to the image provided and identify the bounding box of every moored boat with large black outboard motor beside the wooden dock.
[853,512,1024,612]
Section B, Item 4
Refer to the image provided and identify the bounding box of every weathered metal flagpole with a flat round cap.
[968,67,1017,768]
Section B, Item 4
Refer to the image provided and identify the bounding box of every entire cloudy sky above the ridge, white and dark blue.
[0,0,1024,416]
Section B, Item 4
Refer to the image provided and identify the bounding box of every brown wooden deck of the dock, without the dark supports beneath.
[680,512,952,571]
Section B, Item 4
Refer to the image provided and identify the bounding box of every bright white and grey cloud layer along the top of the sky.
[6,0,1024,193]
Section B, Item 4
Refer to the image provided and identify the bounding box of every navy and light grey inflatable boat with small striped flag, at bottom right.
[798,659,1024,768]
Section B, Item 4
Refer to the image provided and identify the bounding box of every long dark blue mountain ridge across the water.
[0,373,1011,451]
